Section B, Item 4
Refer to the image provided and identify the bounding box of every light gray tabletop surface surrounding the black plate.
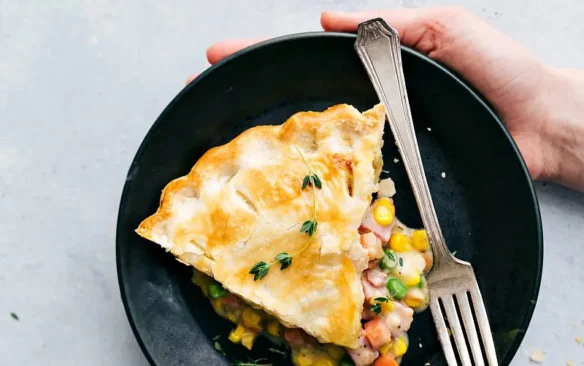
[0,0,584,366]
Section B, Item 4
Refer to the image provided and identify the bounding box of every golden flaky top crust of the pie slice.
[136,104,385,348]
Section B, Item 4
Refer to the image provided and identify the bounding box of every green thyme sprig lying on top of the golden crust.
[249,146,322,281]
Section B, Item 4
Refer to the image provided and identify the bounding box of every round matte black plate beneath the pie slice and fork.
[117,33,543,366]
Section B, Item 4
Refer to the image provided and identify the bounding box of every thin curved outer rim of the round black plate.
[116,32,544,366]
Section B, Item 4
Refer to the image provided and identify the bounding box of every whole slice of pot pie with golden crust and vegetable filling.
[137,105,431,365]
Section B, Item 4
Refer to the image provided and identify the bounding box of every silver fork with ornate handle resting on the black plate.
[355,19,498,366]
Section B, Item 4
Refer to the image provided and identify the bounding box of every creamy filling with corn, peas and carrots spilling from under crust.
[193,180,433,366]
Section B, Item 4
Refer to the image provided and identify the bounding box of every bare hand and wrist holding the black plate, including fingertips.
[187,7,584,191]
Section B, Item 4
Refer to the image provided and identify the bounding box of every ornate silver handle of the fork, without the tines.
[355,18,451,268]
